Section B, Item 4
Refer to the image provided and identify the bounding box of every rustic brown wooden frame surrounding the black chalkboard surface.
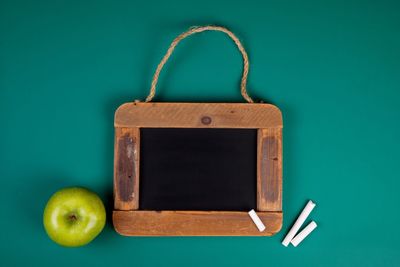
[113,102,283,236]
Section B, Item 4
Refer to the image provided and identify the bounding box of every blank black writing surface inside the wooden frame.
[139,128,257,211]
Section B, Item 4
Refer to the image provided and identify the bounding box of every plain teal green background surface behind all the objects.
[0,0,400,267]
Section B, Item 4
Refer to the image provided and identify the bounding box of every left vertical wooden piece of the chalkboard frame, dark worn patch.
[114,128,140,210]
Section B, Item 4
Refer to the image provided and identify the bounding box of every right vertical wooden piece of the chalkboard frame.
[257,128,282,211]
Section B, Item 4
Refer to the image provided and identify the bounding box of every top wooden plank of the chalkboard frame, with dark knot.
[114,102,282,129]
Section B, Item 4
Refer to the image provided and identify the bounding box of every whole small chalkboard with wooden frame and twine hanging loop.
[113,26,282,236]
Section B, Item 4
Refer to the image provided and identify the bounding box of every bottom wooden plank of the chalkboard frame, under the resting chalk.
[113,210,282,236]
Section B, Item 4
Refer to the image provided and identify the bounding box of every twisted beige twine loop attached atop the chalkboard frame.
[146,26,254,103]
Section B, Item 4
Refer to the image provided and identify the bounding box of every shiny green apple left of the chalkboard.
[43,187,106,247]
